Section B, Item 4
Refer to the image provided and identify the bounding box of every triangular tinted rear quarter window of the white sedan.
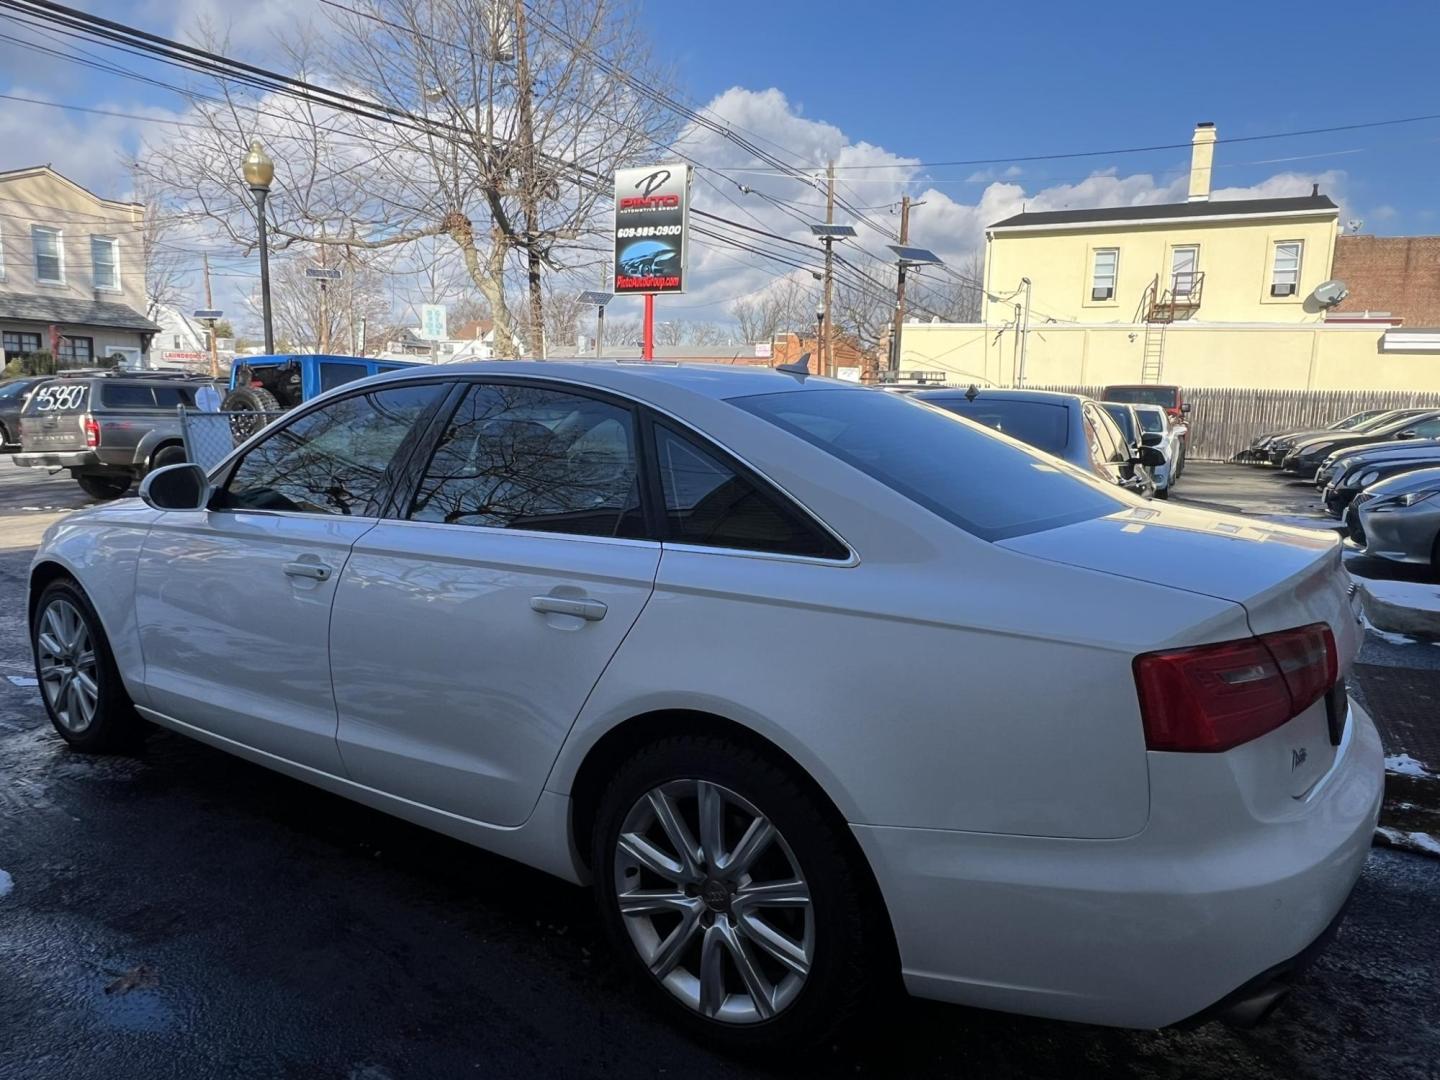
[655,428,848,559]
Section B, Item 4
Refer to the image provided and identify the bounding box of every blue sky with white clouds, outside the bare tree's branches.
[0,0,1440,328]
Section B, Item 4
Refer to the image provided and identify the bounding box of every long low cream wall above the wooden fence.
[900,323,1440,392]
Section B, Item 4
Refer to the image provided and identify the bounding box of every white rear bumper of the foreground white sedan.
[854,703,1384,1028]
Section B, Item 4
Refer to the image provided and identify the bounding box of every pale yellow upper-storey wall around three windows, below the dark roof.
[985,211,1336,327]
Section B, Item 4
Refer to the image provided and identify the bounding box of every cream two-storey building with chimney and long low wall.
[900,124,1440,390]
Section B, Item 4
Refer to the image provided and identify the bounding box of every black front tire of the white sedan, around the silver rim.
[30,577,145,753]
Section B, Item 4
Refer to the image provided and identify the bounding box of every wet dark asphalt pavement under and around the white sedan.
[0,464,1440,1080]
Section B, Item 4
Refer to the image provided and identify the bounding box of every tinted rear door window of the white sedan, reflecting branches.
[409,384,644,536]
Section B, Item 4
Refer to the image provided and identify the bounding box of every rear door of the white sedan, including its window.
[330,380,660,825]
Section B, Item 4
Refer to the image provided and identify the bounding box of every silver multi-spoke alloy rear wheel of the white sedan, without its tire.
[613,779,815,1024]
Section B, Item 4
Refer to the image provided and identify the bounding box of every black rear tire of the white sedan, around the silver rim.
[590,736,881,1054]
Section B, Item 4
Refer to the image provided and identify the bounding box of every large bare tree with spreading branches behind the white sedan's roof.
[138,0,675,354]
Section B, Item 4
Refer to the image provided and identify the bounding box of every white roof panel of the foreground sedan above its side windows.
[365,360,846,400]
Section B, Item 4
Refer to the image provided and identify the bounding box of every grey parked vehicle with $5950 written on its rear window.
[10,372,213,498]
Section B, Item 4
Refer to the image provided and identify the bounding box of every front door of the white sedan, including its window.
[135,382,448,773]
